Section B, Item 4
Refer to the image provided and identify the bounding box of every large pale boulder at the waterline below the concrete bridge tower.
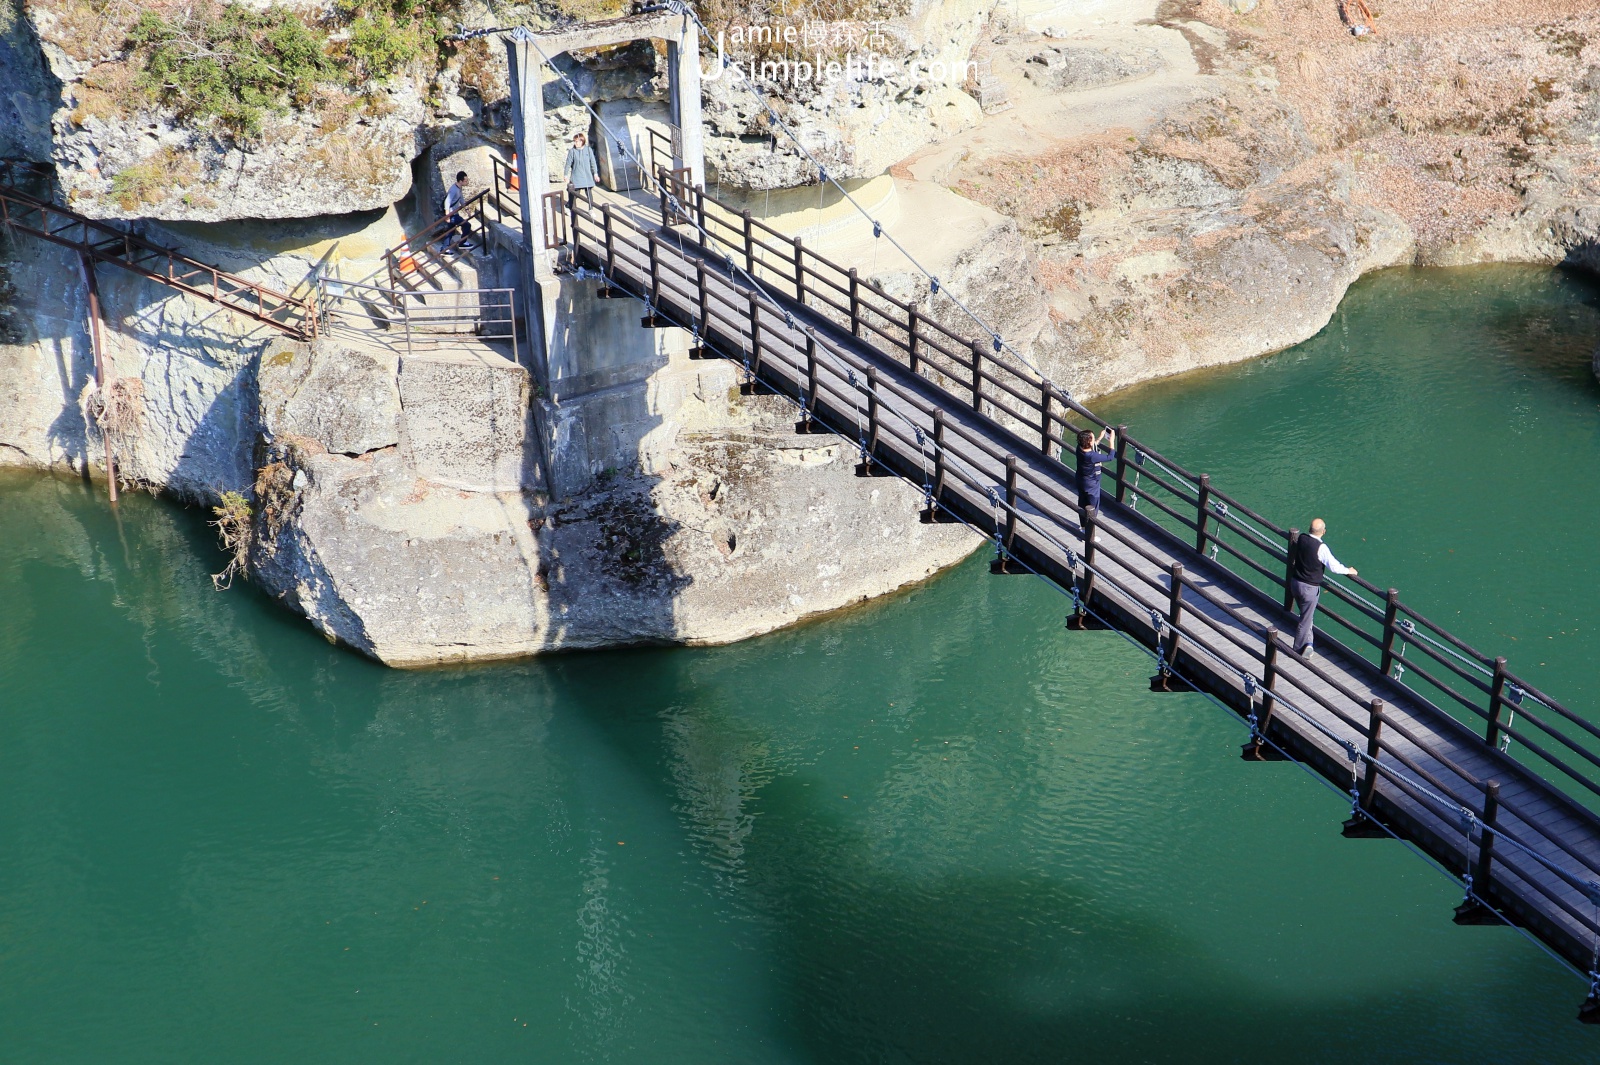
[253,335,979,665]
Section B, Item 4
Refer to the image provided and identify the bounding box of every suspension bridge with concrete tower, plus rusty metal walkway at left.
[9,8,1600,1023]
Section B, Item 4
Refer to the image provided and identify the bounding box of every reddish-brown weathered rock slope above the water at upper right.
[941,0,1600,395]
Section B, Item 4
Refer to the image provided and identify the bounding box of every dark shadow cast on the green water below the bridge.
[560,630,1582,1065]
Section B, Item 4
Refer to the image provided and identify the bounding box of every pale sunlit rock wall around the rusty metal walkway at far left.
[0,203,419,502]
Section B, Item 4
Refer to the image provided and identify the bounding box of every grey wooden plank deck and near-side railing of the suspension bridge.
[553,186,1600,1019]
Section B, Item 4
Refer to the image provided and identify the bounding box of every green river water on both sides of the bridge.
[0,267,1600,1065]
